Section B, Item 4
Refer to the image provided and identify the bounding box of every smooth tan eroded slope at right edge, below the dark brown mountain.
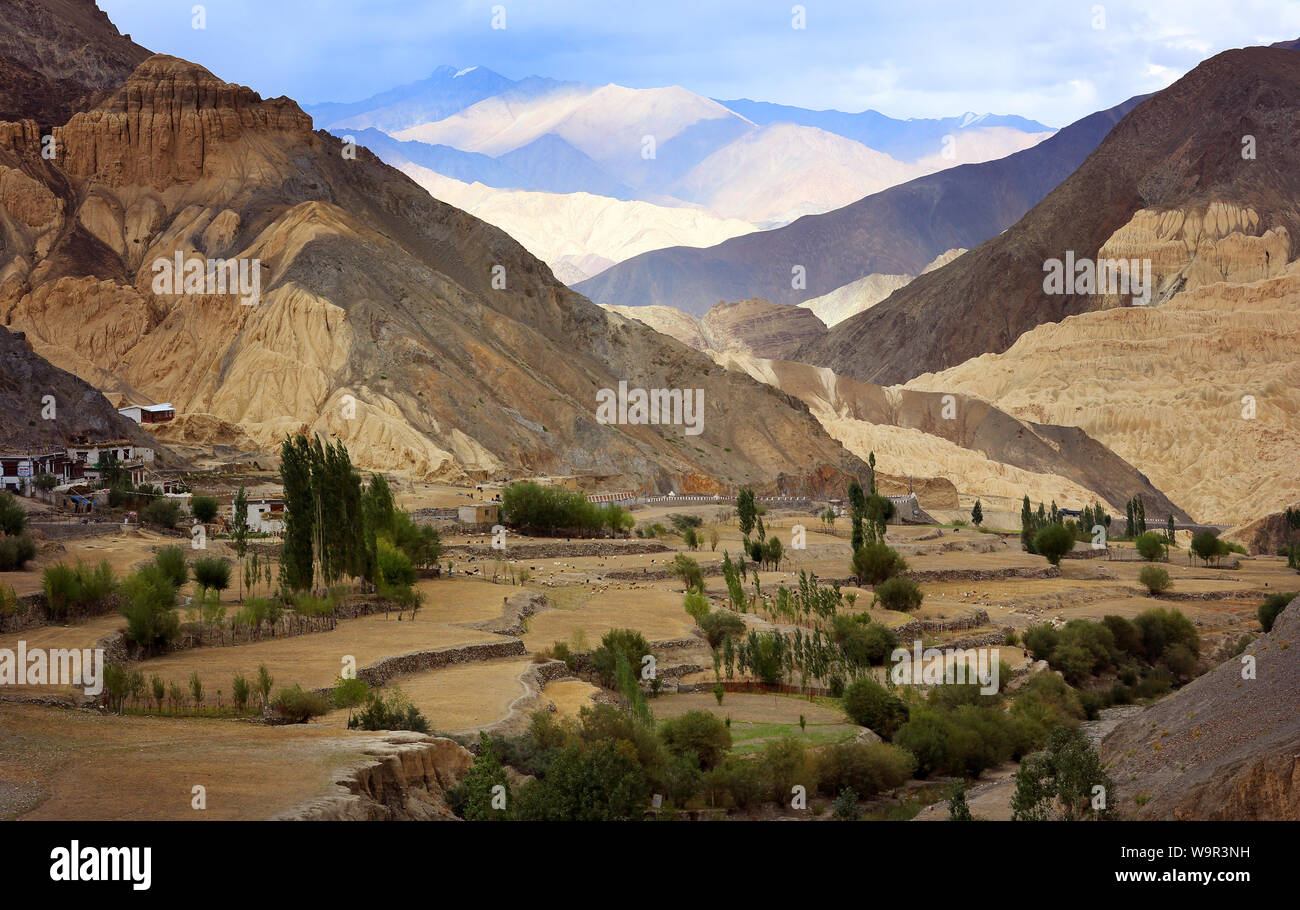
[905,264,1300,525]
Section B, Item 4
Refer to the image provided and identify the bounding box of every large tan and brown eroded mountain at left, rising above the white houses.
[0,56,863,490]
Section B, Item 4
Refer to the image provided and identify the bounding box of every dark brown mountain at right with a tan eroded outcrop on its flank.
[797,47,1300,384]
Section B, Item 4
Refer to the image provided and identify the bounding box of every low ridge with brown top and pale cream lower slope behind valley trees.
[715,352,1186,520]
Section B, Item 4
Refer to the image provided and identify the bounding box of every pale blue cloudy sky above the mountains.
[99,0,1300,126]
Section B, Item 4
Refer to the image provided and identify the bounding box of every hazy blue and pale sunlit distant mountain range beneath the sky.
[306,66,1052,281]
